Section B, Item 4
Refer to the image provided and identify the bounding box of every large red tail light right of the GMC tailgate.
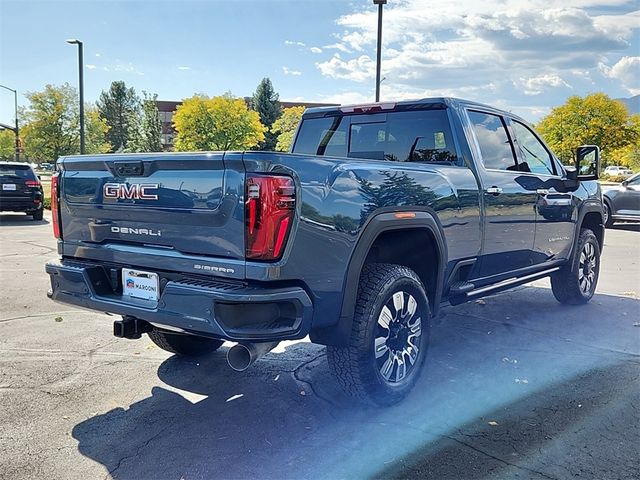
[245,175,296,260]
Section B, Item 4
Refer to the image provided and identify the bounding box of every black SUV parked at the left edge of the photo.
[0,162,44,220]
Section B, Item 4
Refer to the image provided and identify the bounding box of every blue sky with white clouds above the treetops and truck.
[0,0,640,123]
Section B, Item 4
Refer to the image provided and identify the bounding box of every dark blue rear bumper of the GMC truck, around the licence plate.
[46,260,313,341]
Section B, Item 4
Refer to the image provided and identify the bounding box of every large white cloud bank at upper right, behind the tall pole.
[316,0,640,106]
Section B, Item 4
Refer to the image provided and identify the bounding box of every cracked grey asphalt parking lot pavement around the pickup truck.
[0,214,640,480]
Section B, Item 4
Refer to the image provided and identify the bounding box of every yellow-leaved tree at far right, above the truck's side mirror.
[537,93,637,165]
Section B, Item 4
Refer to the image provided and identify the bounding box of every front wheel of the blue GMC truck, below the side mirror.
[551,228,600,305]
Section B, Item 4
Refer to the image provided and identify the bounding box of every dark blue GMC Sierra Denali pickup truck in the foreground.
[46,98,604,405]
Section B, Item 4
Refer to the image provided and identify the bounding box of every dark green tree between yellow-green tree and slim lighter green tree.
[96,81,140,152]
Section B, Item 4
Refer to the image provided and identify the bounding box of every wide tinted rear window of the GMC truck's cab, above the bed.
[293,109,458,163]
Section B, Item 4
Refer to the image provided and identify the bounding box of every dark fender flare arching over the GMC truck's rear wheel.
[311,207,448,345]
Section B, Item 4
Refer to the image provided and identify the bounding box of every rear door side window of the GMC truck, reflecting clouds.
[469,111,518,171]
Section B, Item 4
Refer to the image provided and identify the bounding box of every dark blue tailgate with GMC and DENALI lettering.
[60,153,245,278]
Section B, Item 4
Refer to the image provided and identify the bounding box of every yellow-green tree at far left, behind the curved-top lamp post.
[20,83,110,162]
